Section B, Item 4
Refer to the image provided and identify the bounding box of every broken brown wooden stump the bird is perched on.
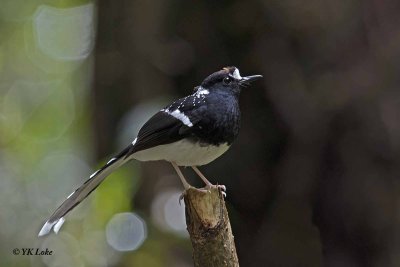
[184,188,239,267]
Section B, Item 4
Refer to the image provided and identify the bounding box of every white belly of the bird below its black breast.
[131,139,229,166]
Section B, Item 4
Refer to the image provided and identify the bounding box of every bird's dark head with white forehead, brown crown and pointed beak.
[201,67,262,94]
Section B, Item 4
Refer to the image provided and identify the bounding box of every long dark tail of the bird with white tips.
[39,145,133,236]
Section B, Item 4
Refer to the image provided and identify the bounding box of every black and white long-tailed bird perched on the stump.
[39,67,262,236]
